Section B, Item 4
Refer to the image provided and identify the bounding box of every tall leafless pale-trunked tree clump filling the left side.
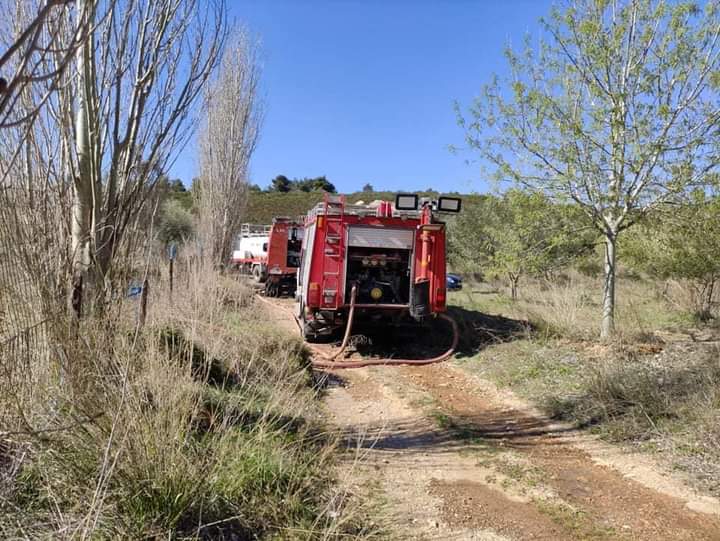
[0,0,226,448]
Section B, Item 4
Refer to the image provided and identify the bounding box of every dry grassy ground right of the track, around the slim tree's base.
[450,281,720,494]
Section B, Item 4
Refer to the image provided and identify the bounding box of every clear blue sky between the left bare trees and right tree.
[171,0,551,192]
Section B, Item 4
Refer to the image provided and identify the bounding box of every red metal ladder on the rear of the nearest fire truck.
[322,195,345,308]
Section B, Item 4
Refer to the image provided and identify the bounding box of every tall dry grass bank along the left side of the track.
[0,262,380,539]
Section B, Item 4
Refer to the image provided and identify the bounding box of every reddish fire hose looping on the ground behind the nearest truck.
[253,286,460,369]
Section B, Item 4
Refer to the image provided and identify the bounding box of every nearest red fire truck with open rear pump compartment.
[296,194,461,341]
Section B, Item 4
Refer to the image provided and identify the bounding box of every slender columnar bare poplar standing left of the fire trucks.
[199,30,262,265]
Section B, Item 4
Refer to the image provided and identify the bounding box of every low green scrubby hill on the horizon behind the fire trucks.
[243,191,480,224]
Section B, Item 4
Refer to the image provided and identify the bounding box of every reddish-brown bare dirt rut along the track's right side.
[399,366,720,540]
